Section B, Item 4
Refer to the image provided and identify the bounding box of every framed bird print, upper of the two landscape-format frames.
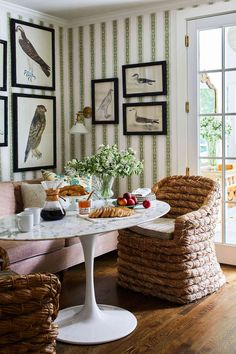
[122,61,167,97]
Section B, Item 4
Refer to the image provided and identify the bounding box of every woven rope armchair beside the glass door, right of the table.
[118,176,225,303]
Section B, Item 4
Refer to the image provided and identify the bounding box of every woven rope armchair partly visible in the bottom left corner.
[0,247,61,354]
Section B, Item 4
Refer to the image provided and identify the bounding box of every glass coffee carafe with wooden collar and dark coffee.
[41,180,66,221]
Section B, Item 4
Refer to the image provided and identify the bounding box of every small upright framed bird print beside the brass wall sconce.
[91,78,119,124]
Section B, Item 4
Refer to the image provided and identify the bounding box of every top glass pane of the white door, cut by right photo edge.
[225,26,236,69]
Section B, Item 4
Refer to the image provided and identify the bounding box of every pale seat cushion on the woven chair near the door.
[130,218,175,240]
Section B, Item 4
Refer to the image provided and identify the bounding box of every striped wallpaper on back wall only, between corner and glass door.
[68,11,171,195]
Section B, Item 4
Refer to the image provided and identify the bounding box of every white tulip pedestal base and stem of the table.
[56,235,137,344]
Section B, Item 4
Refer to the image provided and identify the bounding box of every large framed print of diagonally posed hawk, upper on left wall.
[10,19,55,90]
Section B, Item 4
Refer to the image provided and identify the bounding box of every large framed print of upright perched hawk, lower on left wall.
[13,93,56,172]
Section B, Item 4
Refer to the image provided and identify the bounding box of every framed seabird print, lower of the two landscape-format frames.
[123,102,167,135]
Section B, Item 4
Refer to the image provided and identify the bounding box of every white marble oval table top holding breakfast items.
[0,201,170,241]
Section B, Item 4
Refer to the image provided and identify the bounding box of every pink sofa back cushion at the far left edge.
[0,182,15,216]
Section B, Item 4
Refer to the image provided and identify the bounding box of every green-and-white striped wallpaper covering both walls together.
[0,4,171,195]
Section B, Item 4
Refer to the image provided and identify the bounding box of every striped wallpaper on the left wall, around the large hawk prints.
[0,5,68,181]
